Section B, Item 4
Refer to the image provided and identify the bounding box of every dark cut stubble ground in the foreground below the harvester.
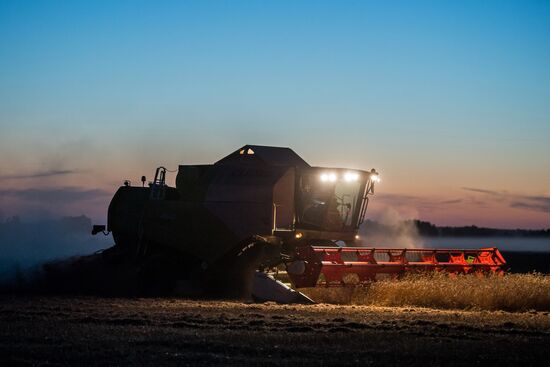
[0,295,550,366]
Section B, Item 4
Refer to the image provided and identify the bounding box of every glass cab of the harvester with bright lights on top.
[297,171,364,231]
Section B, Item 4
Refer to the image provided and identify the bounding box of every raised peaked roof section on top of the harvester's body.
[215,145,310,167]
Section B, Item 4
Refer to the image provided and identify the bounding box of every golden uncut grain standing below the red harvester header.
[302,273,550,312]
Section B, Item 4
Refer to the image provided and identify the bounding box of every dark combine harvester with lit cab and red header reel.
[92,145,505,303]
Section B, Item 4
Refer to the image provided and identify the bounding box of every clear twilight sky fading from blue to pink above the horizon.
[0,0,550,228]
